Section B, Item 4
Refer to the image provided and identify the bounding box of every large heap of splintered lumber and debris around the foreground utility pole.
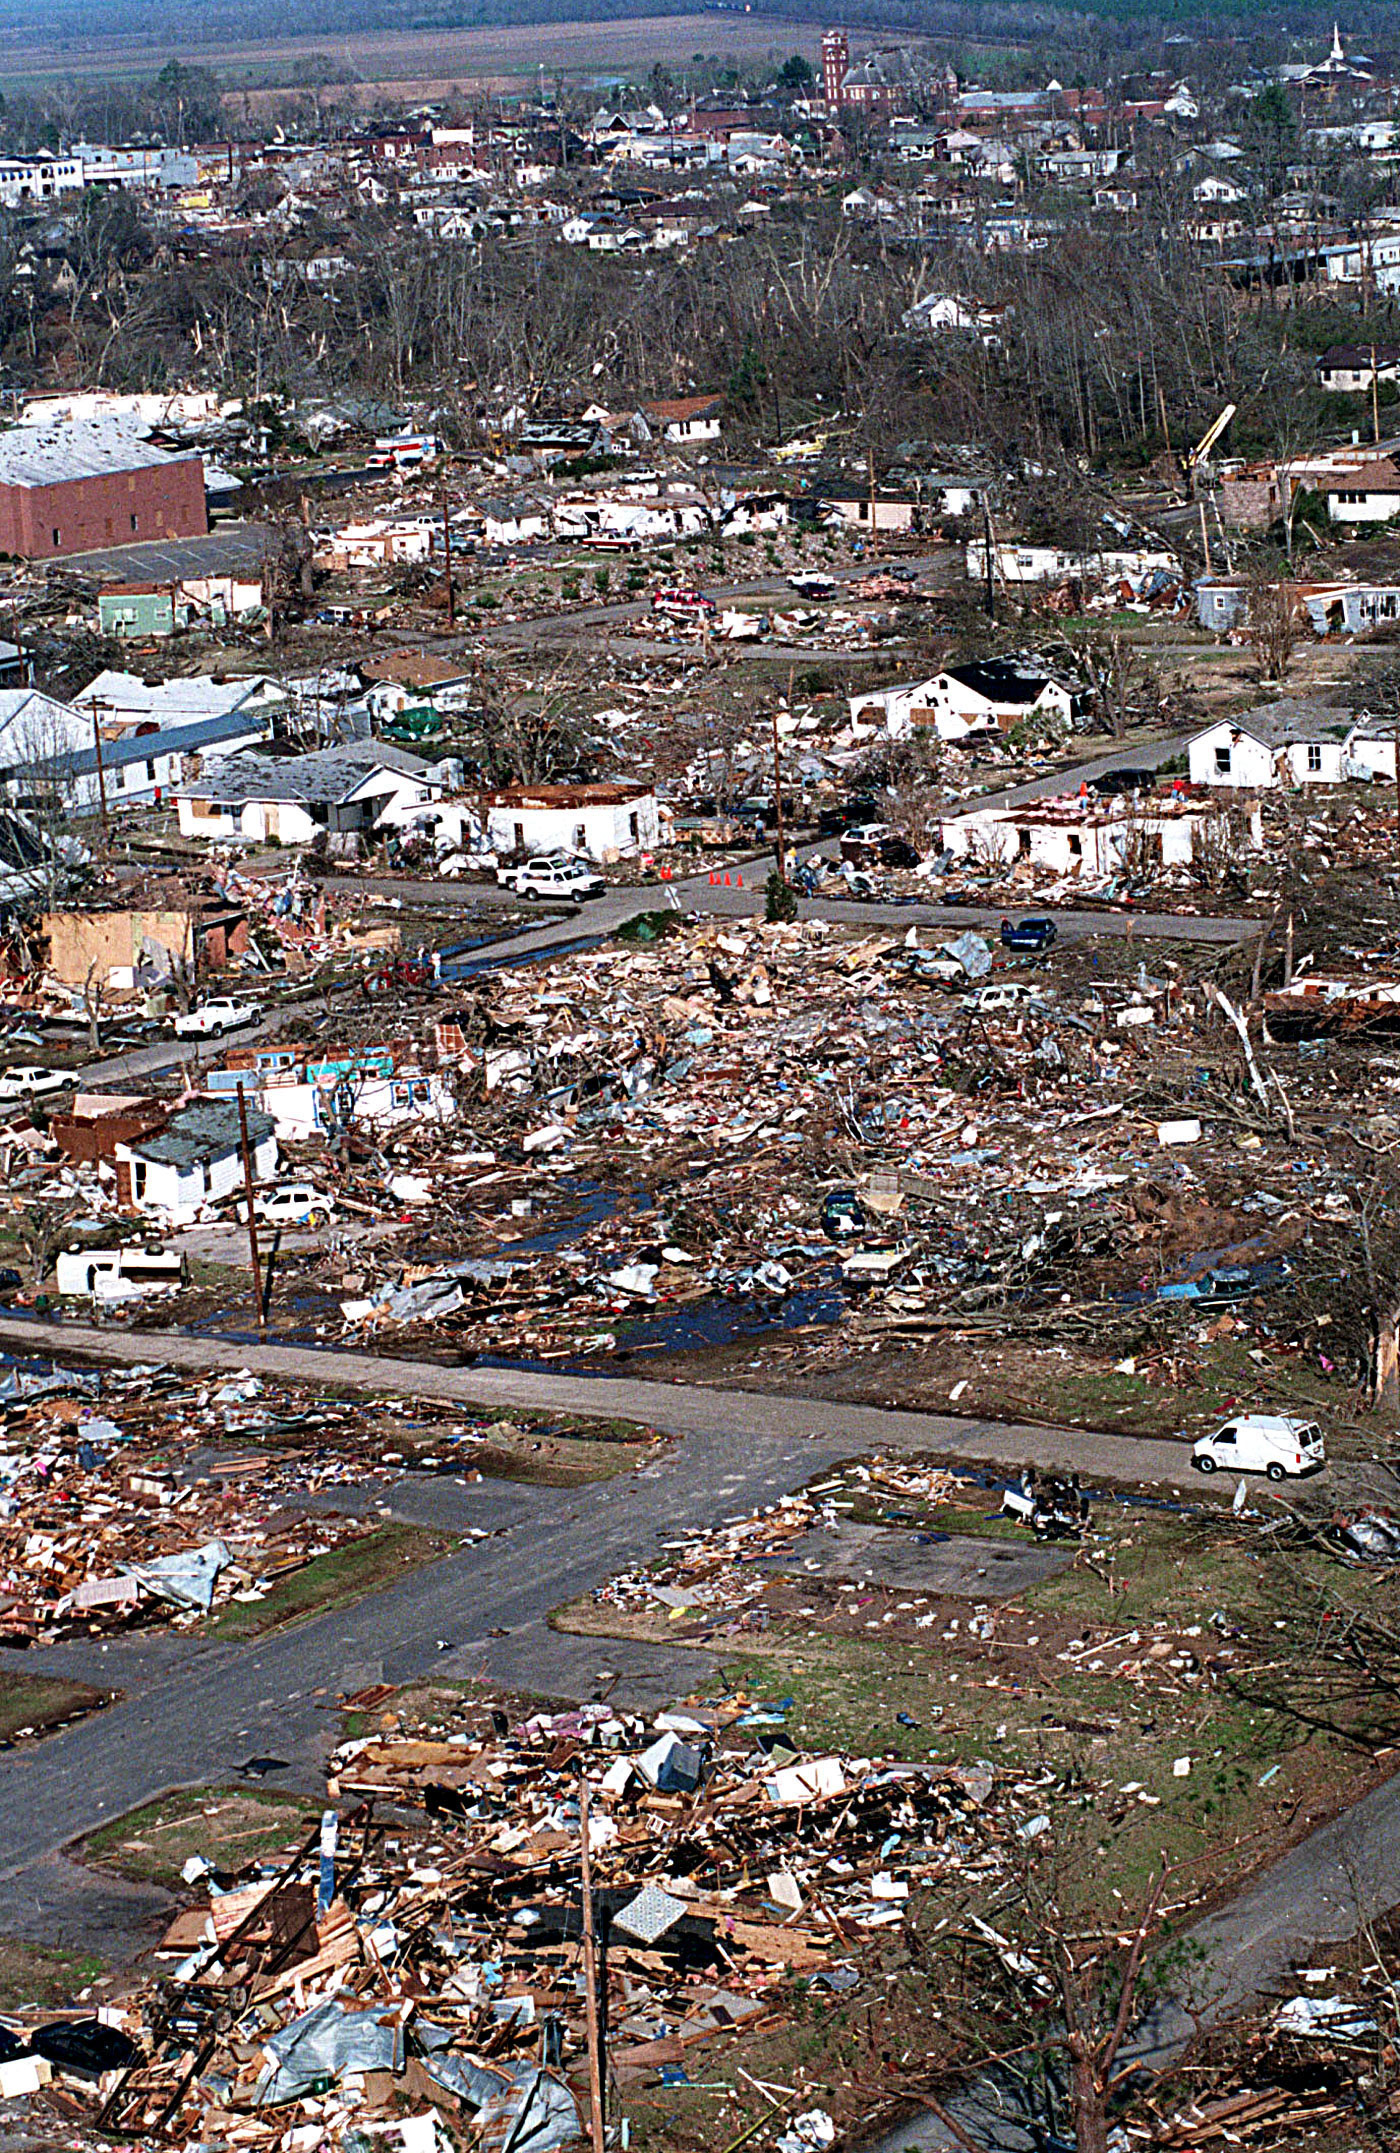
[11,1701,1036,2153]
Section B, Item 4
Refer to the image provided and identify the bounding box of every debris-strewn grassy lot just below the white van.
[556,1488,1400,1929]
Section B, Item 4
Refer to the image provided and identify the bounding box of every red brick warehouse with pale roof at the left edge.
[0,422,209,560]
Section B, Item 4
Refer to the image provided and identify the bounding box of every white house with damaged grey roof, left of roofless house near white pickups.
[174,741,444,844]
